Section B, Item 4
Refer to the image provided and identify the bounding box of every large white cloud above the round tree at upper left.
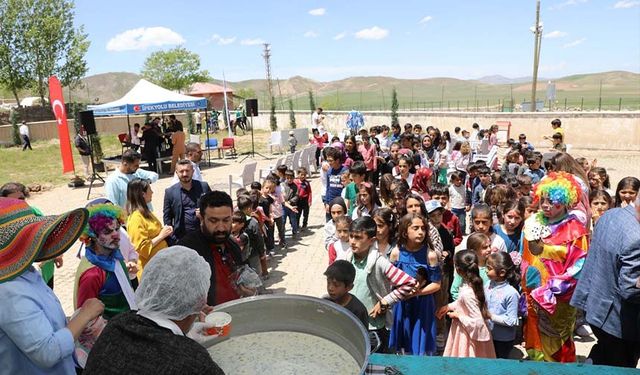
[107,26,185,52]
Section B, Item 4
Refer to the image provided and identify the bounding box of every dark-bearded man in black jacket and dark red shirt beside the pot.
[178,190,248,306]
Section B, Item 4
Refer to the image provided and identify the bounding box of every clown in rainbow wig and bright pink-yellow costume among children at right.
[521,172,588,362]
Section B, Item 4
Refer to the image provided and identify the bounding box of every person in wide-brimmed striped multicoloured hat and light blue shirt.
[0,198,104,374]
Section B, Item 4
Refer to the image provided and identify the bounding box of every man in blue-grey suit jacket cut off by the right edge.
[571,198,640,368]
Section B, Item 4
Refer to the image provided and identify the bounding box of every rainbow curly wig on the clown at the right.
[534,172,582,208]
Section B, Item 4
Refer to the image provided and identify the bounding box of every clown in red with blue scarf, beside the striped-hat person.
[73,204,137,319]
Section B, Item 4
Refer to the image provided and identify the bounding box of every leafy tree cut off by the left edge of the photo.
[0,0,32,106]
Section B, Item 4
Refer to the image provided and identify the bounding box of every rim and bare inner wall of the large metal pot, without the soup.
[204,294,371,374]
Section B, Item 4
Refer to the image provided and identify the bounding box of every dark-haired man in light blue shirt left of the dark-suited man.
[104,150,158,208]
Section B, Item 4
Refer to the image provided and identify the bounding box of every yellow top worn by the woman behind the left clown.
[127,211,169,280]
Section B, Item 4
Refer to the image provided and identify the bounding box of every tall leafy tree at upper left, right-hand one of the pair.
[22,0,90,103]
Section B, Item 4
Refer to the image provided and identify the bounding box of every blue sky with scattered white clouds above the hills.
[75,0,640,82]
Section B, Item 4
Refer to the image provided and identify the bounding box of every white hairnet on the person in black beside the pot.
[136,246,211,320]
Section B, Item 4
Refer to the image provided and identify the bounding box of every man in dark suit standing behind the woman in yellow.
[162,159,211,241]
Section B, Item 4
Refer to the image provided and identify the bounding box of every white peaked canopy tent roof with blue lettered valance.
[88,79,207,116]
